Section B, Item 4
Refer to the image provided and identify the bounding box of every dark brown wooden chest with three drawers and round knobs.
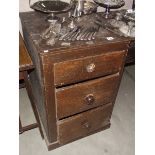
[20,12,129,150]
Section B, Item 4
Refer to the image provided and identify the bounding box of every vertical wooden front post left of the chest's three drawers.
[41,57,57,142]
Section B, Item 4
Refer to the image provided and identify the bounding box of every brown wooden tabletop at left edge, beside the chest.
[19,34,34,71]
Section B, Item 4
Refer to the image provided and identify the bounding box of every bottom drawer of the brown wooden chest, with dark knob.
[58,103,112,144]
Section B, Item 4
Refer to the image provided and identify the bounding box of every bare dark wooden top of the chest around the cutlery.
[20,11,130,53]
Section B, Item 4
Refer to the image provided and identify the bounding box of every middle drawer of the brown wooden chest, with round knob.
[56,73,119,119]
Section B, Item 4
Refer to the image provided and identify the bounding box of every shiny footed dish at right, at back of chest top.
[94,0,125,18]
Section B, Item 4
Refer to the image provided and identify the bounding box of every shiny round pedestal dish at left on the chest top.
[29,0,73,22]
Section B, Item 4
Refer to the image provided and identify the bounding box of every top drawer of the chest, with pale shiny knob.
[54,51,125,86]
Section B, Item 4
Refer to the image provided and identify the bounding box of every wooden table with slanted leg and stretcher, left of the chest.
[19,34,43,138]
